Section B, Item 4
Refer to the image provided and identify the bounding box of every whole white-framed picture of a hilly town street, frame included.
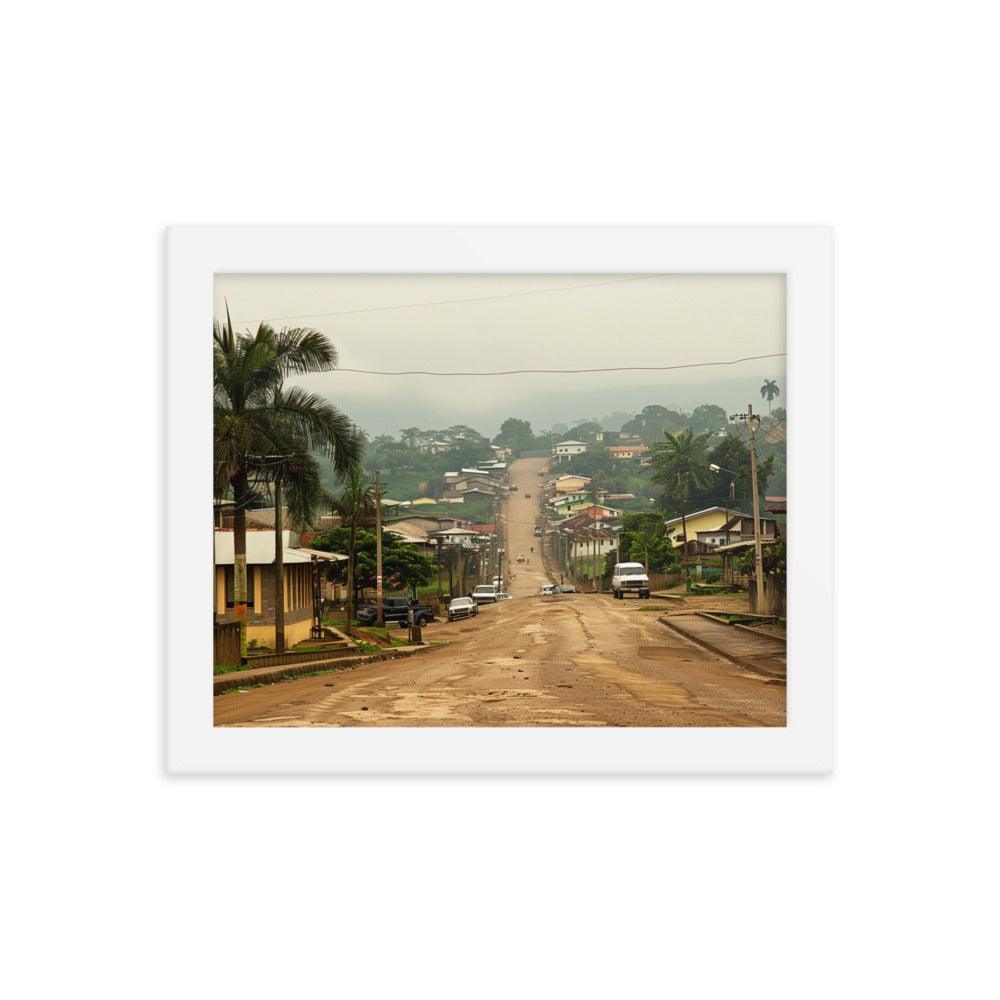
[166,226,834,773]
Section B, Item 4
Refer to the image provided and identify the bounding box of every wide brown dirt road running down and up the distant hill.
[214,460,785,726]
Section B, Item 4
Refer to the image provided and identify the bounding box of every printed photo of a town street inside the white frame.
[213,273,788,727]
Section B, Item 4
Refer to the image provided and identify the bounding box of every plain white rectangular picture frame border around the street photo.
[165,226,834,774]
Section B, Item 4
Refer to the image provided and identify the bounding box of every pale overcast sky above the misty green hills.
[215,274,785,436]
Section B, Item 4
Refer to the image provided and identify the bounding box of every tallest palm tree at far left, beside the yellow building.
[212,305,358,653]
